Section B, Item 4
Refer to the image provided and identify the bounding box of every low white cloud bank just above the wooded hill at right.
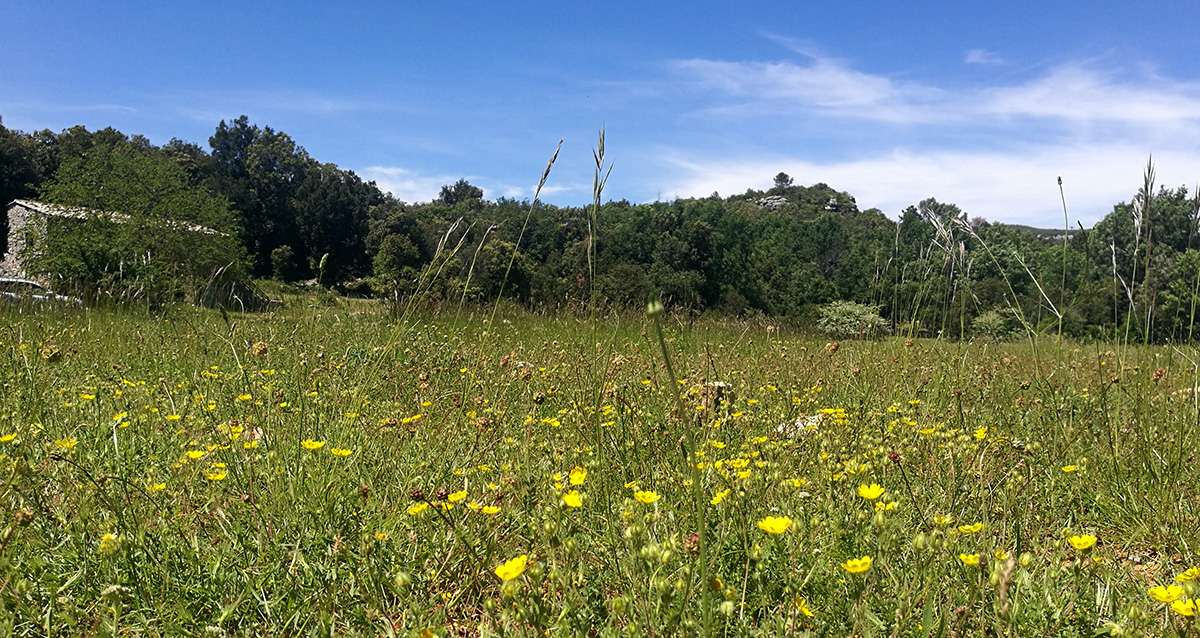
[665,143,1200,227]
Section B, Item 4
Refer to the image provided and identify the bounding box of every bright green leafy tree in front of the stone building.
[31,144,242,305]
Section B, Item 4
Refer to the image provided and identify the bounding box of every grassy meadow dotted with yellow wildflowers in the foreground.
[0,302,1200,636]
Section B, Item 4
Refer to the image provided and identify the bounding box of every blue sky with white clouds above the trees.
[0,1,1200,225]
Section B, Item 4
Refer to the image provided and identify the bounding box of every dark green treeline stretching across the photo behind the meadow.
[0,116,1200,341]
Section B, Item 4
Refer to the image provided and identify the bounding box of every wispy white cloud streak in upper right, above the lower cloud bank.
[670,55,1200,126]
